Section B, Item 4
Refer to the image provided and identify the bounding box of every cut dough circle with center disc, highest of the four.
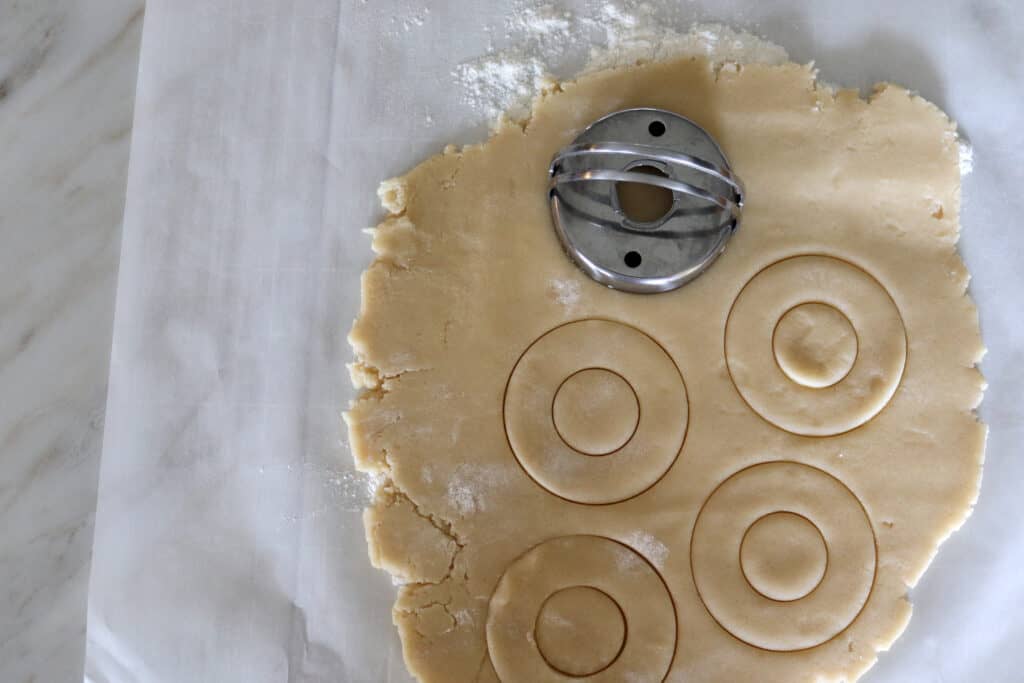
[725,255,906,436]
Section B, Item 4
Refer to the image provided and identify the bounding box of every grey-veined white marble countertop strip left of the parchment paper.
[0,0,144,683]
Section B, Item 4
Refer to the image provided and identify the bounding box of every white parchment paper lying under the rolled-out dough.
[86,0,1024,683]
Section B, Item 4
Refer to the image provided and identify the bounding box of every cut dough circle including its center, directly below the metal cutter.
[504,319,689,505]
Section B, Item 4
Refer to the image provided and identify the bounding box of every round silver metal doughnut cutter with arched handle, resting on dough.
[548,109,743,293]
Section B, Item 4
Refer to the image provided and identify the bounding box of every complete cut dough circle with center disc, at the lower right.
[690,461,878,651]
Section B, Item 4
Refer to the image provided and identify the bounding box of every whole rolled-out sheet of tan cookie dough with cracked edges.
[346,59,985,683]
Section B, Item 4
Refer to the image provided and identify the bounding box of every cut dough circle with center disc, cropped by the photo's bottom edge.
[486,536,676,683]
